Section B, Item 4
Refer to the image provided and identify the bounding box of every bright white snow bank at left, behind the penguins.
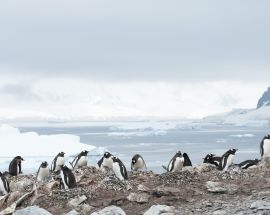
[0,125,96,157]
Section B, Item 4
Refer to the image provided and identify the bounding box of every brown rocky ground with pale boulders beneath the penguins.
[0,164,270,215]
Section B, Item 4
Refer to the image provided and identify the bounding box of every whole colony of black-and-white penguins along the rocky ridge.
[0,135,270,196]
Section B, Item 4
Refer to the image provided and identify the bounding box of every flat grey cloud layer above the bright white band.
[0,0,270,81]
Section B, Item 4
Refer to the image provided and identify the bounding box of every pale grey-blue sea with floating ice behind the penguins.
[20,122,270,173]
